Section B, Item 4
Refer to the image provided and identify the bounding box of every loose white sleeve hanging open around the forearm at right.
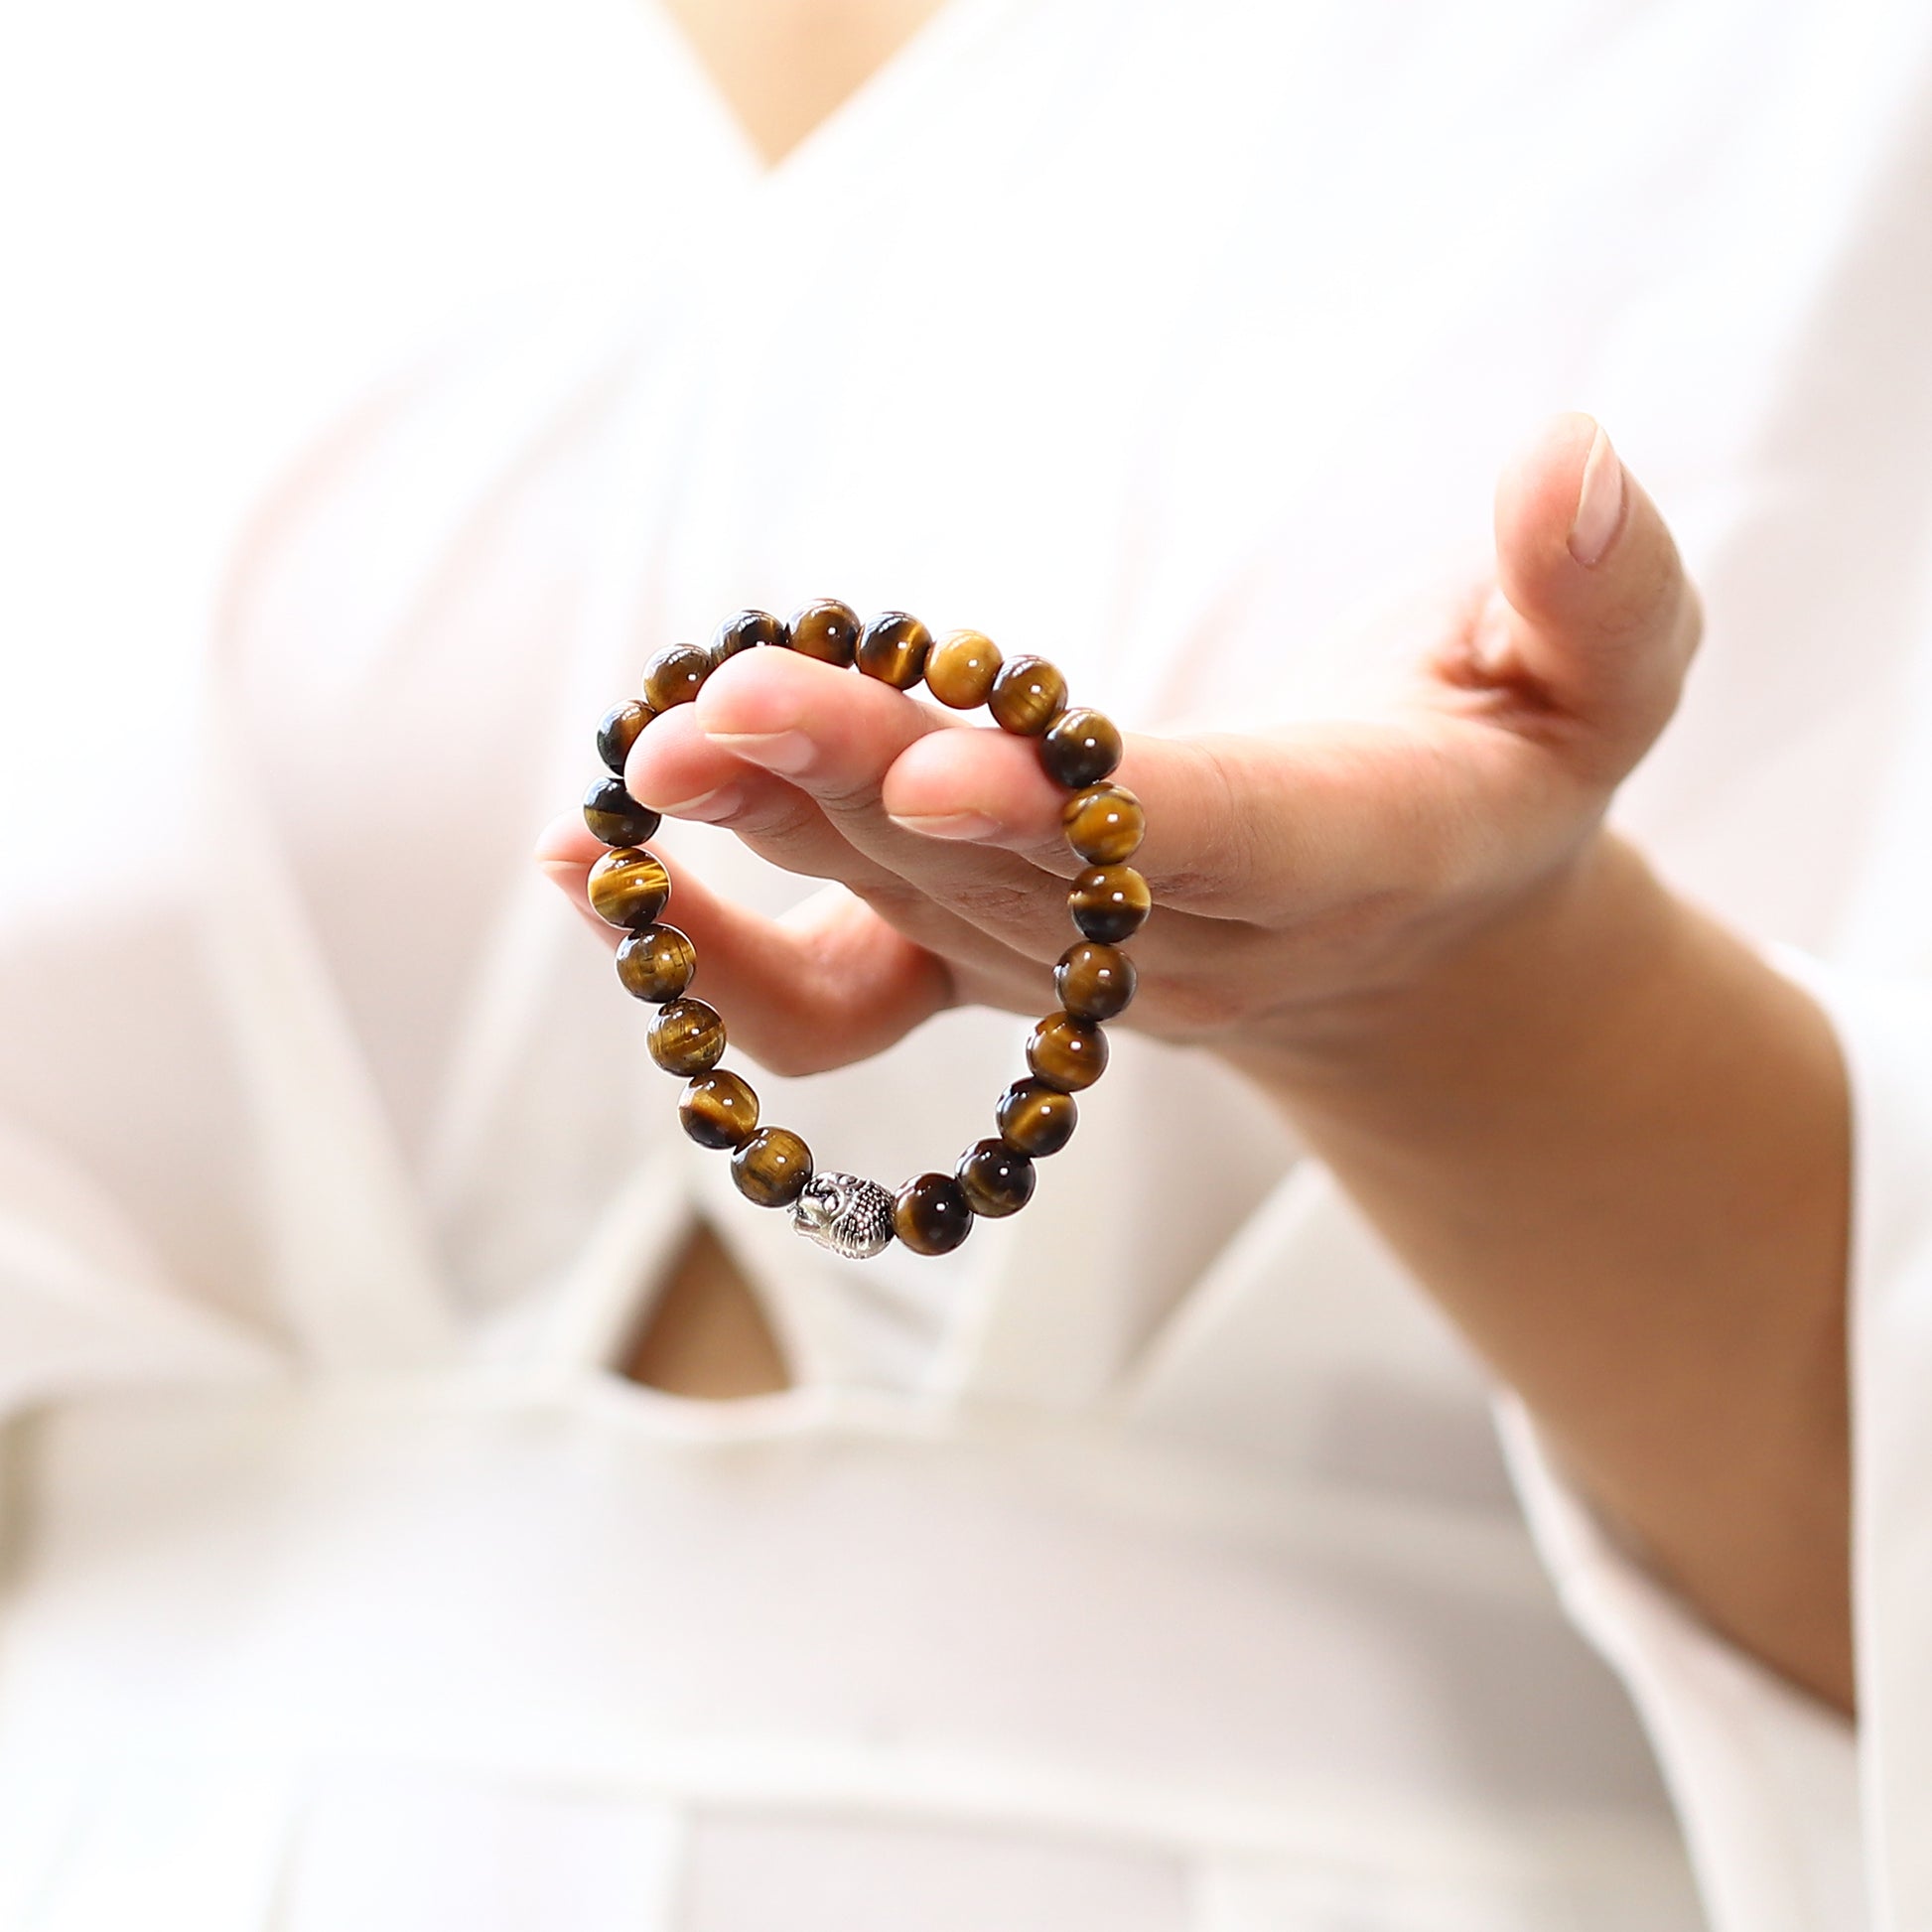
[1503,954,1932,1932]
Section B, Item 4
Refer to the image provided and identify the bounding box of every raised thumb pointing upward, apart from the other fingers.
[1470,415,1700,780]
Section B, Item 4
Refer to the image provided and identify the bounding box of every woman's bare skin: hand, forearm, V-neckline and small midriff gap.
[564,0,1853,1712]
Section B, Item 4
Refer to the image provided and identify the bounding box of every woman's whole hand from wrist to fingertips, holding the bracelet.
[539,417,1699,1074]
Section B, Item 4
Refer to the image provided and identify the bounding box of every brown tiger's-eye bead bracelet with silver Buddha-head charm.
[584,599,1152,1260]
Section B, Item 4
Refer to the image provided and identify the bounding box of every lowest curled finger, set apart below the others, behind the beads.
[537,821,954,1074]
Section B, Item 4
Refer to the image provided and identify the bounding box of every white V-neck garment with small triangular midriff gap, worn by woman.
[0,0,1932,1932]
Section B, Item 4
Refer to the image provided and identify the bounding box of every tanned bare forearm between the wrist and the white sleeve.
[1236,839,1851,1708]
